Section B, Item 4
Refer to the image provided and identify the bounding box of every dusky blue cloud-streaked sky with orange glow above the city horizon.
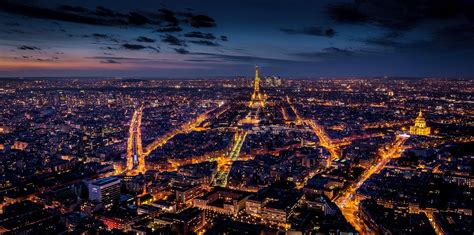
[0,0,474,78]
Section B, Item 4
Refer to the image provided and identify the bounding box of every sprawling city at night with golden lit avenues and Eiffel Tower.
[0,67,473,234]
